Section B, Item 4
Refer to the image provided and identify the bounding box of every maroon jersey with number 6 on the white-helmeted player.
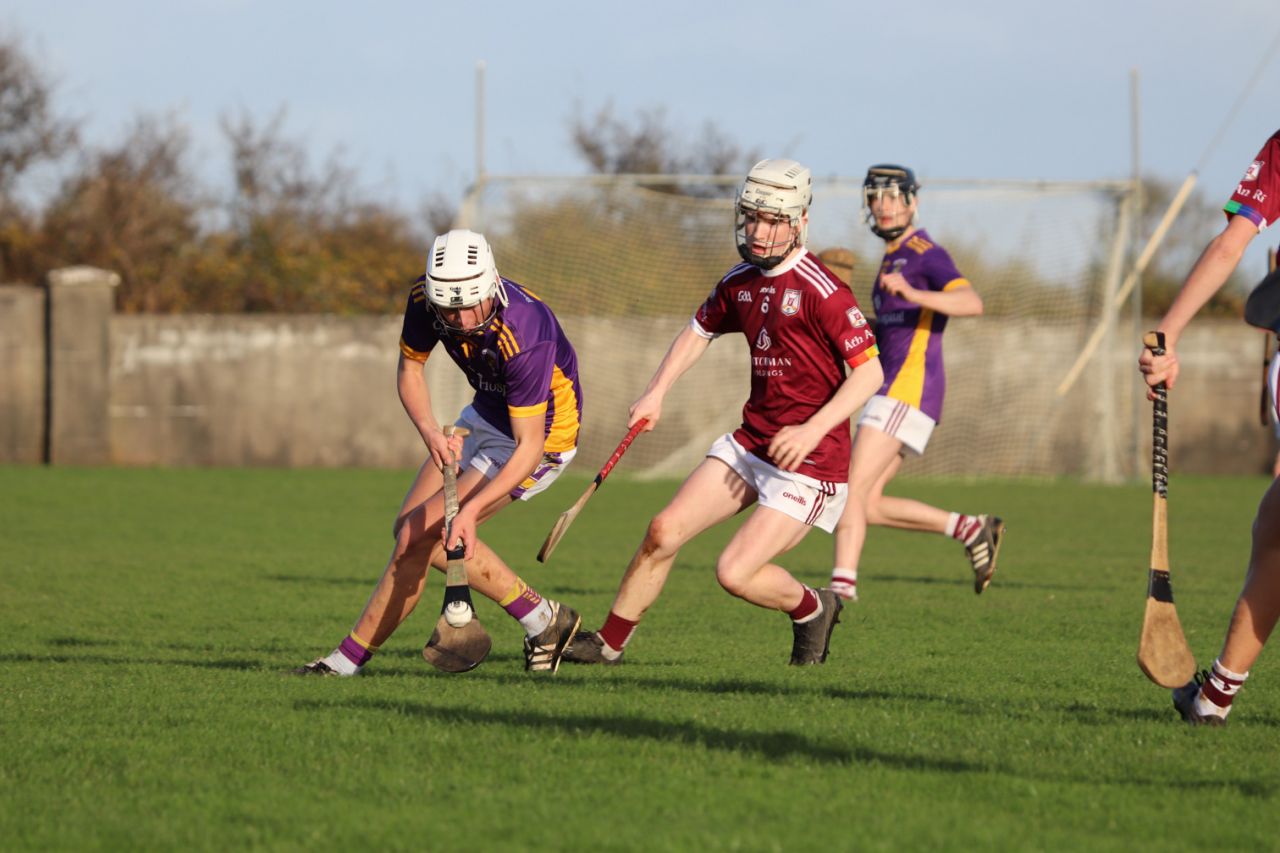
[692,250,878,483]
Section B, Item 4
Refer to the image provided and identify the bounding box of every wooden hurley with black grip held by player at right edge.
[1138,332,1196,689]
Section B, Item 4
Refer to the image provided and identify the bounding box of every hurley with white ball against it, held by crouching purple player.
[422,424,493,672]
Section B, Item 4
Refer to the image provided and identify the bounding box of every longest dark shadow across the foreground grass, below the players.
[294,699,987,772]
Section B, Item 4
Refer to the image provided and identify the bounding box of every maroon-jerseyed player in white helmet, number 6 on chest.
[564,160,883,665]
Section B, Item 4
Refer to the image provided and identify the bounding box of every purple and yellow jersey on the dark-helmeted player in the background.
[872,229,969,421]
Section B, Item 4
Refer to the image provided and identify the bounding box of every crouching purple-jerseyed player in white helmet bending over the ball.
[296,231,582,675]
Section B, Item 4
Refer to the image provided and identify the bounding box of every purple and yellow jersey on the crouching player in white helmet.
[401,277,582,453]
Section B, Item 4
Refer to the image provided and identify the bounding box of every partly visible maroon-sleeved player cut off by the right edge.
[1138,131,1280,725]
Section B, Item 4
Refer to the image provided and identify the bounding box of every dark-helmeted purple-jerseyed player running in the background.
[831,164,1005,601]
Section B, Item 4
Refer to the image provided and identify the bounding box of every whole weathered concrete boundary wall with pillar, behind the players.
[0,279,1275,476]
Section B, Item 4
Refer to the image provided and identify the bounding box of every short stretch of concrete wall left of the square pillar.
[0,284,47,465]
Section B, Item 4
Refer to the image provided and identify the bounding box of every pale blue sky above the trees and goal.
[0,0,1280,268]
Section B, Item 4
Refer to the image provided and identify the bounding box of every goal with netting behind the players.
[457,175,1142,480]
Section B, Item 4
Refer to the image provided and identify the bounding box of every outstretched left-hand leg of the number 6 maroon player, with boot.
[564,459,756,663]
